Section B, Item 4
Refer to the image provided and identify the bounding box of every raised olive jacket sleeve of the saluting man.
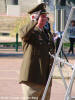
[20,15,37,39]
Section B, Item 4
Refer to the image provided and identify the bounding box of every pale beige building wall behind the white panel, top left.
[0,0,41,14]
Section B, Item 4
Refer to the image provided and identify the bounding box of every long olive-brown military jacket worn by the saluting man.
[19,14,54,85]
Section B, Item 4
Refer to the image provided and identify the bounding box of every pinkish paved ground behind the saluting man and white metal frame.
[0,50,75,100]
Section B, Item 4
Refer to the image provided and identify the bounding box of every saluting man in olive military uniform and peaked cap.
[19,3,52,100]
